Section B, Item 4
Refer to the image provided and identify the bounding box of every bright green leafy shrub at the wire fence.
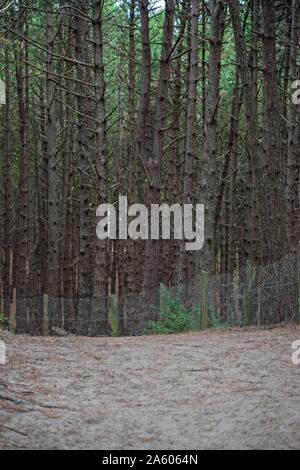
[145,288,193,335]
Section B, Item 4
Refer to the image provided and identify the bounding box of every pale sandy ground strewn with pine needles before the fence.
[0,328,300,450]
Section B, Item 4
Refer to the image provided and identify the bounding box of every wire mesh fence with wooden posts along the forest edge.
[0,253,300,336]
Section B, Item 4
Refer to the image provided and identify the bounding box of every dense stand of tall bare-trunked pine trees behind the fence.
[0,0,300,335]
